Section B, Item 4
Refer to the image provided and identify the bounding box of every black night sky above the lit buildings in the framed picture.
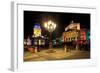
[24,11,90,38]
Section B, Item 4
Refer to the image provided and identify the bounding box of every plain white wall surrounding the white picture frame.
[0,0,100,73]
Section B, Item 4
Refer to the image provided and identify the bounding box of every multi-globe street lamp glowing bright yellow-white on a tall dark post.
[44,20,56,52]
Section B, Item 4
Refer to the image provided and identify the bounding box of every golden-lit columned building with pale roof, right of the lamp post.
[63,21,80,50]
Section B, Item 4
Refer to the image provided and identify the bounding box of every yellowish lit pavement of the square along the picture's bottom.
[24,49,90,61]
